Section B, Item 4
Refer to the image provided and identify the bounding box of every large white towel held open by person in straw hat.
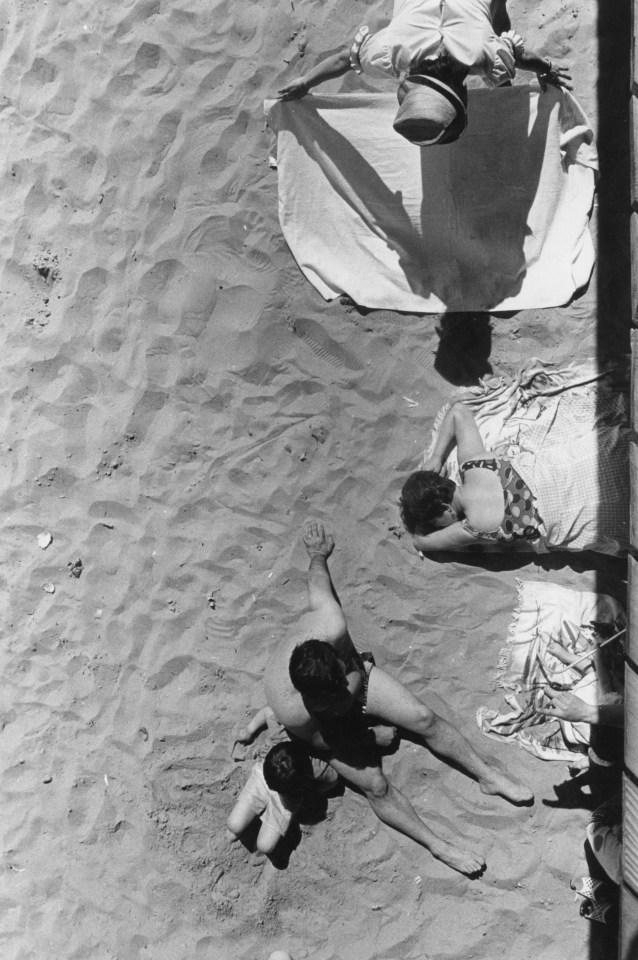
[265,83,597,313]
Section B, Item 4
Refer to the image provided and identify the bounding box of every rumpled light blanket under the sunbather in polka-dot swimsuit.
[423,360,630,555]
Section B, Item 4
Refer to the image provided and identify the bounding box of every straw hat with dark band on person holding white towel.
[393,73,467,147]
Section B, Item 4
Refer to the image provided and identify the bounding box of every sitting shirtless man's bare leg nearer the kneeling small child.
[330,758,485,877]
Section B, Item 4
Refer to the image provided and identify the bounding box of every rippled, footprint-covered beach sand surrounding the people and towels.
[0,0,630,960]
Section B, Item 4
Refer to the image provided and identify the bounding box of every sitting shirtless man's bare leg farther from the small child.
[368,667,534,803]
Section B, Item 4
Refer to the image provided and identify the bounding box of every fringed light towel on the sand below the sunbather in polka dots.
[476,580,626,763]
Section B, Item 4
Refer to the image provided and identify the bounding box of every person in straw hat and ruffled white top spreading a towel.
[279,0,571,147]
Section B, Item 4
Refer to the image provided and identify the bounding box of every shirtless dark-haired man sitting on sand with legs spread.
[266,521,533,876]
